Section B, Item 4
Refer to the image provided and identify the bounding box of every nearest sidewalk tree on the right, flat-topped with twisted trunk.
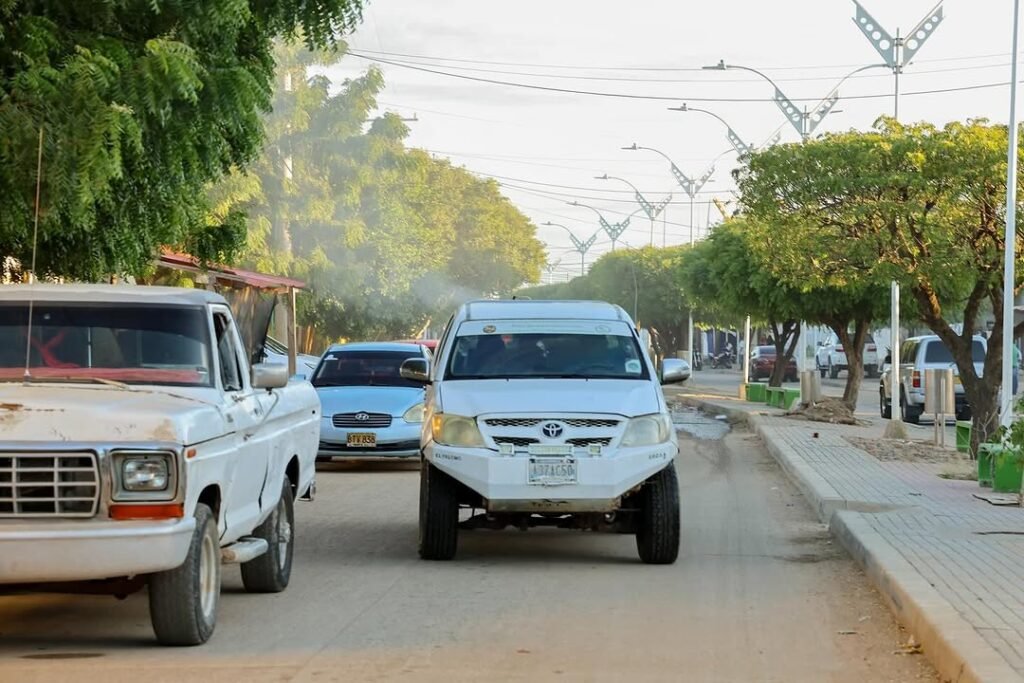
[740,119,1021,443]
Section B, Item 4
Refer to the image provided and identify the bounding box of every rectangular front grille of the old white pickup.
[0,453,99,517]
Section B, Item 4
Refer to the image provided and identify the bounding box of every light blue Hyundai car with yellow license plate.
[312,342,430,461]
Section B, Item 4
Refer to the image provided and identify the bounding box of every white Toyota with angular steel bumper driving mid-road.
[402,301,689,564]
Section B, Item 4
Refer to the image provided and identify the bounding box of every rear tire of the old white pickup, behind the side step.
[236,478,295,593]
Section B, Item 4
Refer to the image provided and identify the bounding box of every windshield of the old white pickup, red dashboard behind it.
[0,302,212,386]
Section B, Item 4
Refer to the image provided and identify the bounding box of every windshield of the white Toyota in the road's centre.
[446,332,649,380]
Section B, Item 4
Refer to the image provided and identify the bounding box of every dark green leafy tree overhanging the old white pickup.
[0,0,361,279]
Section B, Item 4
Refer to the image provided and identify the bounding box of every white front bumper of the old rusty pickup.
[0,517,196,584]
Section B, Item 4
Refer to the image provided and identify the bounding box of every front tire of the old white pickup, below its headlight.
[150,503,220,645]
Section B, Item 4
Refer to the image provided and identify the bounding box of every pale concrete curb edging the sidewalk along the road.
[673,394,1024,683]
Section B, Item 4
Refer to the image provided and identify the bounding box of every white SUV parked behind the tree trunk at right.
[879,335,988,424]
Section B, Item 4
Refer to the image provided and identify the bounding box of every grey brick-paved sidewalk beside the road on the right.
[667,387,1024,678]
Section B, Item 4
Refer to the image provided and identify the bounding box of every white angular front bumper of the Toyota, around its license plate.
[424,442,679,512]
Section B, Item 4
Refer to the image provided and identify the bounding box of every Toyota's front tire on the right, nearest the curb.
[637,463,679,564]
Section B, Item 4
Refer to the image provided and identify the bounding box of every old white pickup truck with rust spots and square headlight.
[0,285,319,645]
